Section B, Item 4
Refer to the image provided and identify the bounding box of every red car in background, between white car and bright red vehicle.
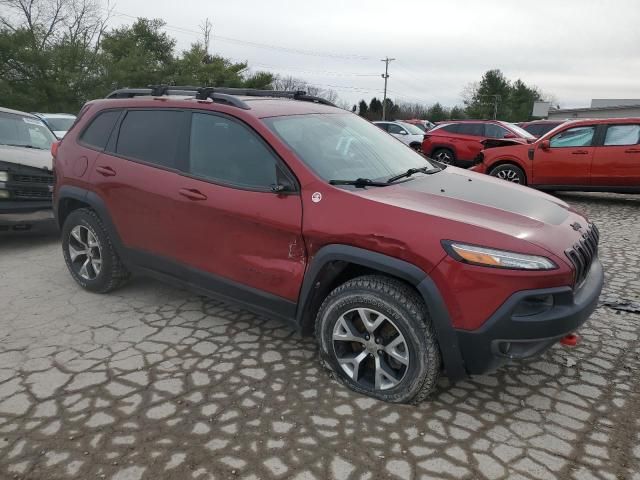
[422,120,535,167]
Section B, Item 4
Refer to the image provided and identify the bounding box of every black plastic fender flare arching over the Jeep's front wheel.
[296,244,467,381]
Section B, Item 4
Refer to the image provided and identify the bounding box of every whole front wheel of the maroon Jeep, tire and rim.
[316,275,441,403]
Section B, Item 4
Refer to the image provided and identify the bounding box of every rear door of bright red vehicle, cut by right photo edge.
[591,123,640,187]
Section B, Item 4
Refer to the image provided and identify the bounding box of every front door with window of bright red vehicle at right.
[530,125,596,186]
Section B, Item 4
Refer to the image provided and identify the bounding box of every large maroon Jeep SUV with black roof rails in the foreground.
[54,87,603,402]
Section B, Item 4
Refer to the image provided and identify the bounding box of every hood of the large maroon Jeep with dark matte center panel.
[364,167,587,256]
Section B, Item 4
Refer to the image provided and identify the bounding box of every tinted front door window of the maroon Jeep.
[189,113,277,188]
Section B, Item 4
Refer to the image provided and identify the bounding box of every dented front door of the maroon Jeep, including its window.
[171,112,306,304]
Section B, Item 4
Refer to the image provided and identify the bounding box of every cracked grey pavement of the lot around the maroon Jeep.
[0,194,640,480]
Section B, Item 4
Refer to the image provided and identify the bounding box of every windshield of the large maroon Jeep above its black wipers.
[264,113,434,180]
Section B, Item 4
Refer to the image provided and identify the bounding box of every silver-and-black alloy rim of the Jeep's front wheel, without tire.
[332,308,409,390]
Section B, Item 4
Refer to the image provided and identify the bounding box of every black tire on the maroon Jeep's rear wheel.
[61,208,130,293]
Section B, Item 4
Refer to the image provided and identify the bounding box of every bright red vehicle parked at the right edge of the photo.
[472,118,640,193]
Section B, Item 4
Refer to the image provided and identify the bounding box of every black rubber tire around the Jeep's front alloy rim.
[316,275,441,403]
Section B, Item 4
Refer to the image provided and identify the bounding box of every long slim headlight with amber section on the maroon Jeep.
[443,242,558,270]
